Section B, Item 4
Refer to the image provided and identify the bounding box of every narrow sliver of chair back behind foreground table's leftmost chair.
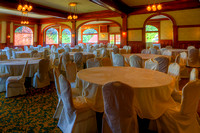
[53,68,60,98]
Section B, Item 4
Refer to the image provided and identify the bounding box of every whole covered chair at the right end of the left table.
[33,59,50,88]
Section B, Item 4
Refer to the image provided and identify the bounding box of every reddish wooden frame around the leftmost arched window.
[13,25,35,47]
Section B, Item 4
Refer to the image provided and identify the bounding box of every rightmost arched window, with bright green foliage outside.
[146,25,159,43]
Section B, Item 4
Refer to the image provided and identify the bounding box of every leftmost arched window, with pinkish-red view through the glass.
[14,26,33,46]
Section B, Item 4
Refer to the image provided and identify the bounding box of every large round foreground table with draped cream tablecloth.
[77,67,175,119]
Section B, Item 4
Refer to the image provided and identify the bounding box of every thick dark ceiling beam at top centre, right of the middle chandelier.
[90,0,132,14]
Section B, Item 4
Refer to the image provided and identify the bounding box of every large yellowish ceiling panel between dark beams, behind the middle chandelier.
[31,0,107,13]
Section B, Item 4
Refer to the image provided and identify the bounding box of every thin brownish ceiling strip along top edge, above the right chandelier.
[122,0,175,6]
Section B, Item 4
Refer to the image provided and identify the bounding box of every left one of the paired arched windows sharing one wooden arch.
[46,28,58,44]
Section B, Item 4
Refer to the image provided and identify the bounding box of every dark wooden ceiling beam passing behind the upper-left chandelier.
[0,0,69,19]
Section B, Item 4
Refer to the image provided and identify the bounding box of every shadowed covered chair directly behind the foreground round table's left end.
[74,52,83,71]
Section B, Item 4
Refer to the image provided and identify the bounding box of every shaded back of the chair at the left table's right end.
[38,59,49,82]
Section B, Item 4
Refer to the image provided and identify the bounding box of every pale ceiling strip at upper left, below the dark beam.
[0,7,52,19]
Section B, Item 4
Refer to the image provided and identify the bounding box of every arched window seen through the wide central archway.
[83,29,98,43]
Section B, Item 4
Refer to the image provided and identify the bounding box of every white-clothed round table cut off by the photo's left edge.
[0,58,41,77]
